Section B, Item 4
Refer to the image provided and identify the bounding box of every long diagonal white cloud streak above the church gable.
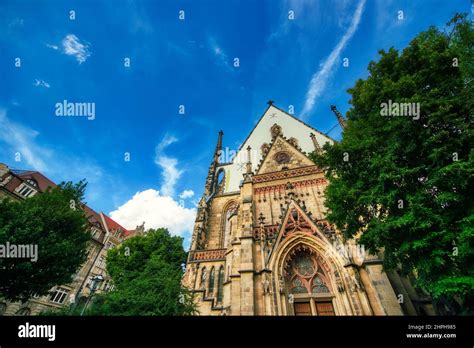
[301,0,365,118]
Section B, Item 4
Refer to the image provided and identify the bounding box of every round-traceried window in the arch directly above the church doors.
[285,247,331,294]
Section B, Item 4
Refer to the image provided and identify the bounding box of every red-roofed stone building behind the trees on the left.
[0,163,131,315]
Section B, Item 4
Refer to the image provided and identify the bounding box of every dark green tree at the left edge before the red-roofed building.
[0,181,90,301]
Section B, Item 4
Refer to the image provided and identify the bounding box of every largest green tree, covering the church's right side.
[312,15,474,312]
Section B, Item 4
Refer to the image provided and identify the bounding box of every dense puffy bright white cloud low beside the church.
[110,189,196,236]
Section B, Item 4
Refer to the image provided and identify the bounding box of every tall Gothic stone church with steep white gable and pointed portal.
[183,101,436,315]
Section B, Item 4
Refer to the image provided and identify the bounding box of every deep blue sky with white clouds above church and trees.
[0,0,471,245]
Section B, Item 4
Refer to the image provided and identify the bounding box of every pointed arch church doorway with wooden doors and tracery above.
[284,245,335,316]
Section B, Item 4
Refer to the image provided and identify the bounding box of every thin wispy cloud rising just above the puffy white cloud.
[155,134,183,197]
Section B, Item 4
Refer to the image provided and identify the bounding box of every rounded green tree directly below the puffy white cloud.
[86,228,195,315]
